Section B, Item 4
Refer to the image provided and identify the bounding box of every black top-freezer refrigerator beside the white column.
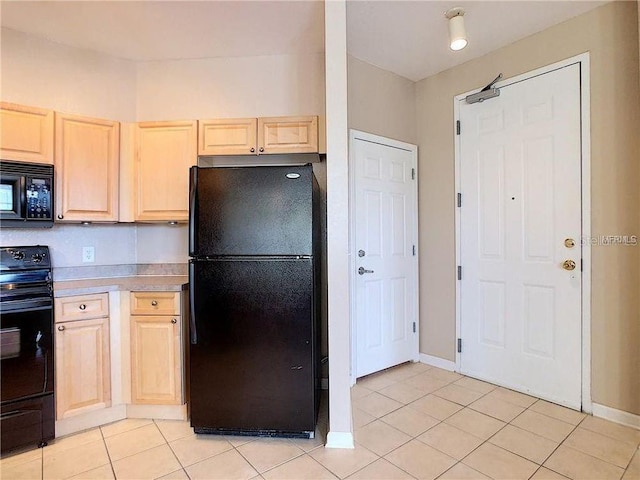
[189,165,321,437]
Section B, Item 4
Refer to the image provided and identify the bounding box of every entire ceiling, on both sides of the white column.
[0,0,606,80]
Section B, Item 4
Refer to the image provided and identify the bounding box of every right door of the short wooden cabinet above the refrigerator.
[258,116,318,153]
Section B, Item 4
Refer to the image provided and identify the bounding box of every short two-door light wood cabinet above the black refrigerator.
[198,116,318,155]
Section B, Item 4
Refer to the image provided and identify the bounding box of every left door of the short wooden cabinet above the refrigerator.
[198,118,258,155]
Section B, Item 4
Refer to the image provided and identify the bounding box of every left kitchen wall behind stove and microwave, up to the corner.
[0,28,136,267]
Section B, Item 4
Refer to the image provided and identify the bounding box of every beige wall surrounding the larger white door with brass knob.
[417,2,640,414]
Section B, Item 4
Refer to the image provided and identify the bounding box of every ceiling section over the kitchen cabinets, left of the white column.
[0,0,324,61]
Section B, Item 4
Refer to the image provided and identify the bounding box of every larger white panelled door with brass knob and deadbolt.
[458,64,582,409]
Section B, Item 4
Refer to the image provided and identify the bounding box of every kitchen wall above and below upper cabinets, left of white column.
[0,29,326,267]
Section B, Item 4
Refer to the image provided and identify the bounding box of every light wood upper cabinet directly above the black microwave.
[0,102,53,164]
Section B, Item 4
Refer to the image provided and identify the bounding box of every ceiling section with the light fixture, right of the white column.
[347,0,607,81]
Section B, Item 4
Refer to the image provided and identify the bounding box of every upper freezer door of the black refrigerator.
[191,166,314,256]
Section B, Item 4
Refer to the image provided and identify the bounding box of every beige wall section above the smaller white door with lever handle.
[347,55,417,144]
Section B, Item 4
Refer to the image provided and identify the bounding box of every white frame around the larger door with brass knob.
[453,52,593,413]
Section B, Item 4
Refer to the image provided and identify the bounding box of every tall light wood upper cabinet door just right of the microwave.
[55,113,120,222]
